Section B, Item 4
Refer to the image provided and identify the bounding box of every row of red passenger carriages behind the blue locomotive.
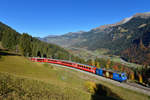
[30,58,96,73]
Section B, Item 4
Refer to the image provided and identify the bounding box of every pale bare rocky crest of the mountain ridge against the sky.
[43,12,150,47]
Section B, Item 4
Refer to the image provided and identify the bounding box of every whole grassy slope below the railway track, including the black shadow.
[0,50,149,100]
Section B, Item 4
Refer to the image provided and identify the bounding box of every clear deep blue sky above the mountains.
[0,0,150,37]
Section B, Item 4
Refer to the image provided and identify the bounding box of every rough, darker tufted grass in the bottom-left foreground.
[0,73,77,100]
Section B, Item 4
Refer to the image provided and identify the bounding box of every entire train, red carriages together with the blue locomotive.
[30,58,127,82]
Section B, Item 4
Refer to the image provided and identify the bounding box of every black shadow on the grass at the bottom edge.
[91,84,123,100]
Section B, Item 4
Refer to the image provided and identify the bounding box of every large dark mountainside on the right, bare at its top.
[44,13,150,64]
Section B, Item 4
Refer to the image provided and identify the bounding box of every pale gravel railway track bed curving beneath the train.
[51,64,150,96]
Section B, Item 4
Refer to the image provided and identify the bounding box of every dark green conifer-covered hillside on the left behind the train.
[0,22,84,62]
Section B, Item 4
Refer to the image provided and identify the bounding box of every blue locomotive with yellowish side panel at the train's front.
[96,68,127,82]
